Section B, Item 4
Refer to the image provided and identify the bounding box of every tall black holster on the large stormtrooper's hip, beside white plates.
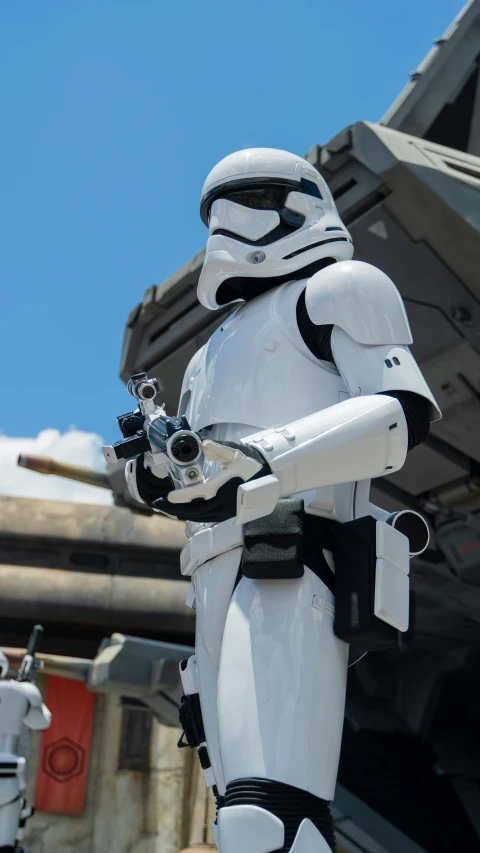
[331,515,399,651]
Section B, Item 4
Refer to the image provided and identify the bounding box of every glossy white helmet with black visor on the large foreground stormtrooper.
[198,148,353,310]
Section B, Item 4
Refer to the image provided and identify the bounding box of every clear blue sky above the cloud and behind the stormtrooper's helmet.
[0,0,461,440]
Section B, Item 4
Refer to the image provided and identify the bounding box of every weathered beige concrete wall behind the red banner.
[24,679,215,853]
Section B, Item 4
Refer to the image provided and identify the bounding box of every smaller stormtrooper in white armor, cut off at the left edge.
[0,652,51,851]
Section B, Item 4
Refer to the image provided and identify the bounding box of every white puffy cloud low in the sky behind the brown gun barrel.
[0,428,112,504]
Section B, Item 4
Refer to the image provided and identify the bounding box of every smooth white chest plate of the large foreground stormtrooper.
[186,281,350,430]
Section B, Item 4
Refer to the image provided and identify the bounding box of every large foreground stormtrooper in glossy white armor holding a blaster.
[127,148,440,853]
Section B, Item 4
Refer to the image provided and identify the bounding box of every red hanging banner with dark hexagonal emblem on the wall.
[35,676,95,815]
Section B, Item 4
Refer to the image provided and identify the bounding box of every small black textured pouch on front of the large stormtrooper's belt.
[242,498,305,580]
